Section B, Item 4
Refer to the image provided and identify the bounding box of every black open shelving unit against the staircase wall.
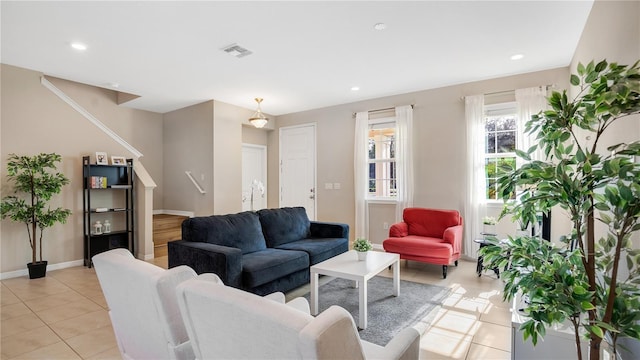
[82,156,135,267]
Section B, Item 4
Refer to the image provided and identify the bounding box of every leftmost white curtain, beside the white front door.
[353,111,369,238]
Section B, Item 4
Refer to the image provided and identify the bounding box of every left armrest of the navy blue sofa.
[167,240,242,288]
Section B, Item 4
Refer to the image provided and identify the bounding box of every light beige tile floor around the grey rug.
[0,257,511,360]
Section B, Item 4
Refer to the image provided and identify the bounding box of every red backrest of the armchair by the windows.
[402,208,462,238]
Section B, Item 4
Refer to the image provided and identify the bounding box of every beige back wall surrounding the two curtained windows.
[269,68,568,245]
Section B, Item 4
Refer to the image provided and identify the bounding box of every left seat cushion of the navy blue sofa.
[242,249,310,289]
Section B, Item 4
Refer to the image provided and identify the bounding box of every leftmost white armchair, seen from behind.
[93,249,222,360]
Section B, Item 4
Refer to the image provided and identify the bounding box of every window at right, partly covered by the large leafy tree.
[484,103,519,200]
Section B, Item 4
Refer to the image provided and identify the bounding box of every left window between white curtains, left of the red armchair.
[368,119,397,198]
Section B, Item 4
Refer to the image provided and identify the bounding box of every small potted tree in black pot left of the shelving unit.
[0,153,71,279]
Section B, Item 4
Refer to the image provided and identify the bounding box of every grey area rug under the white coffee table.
[304,276,451,346]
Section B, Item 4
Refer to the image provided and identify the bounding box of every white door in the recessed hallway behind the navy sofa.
[242,144,267,211]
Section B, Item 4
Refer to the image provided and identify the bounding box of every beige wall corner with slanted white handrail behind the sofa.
[163,100,275,216]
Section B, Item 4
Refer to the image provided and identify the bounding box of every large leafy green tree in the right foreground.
[481,60,640,360]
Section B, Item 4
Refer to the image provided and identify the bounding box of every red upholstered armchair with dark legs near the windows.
[382,208,462,279]
